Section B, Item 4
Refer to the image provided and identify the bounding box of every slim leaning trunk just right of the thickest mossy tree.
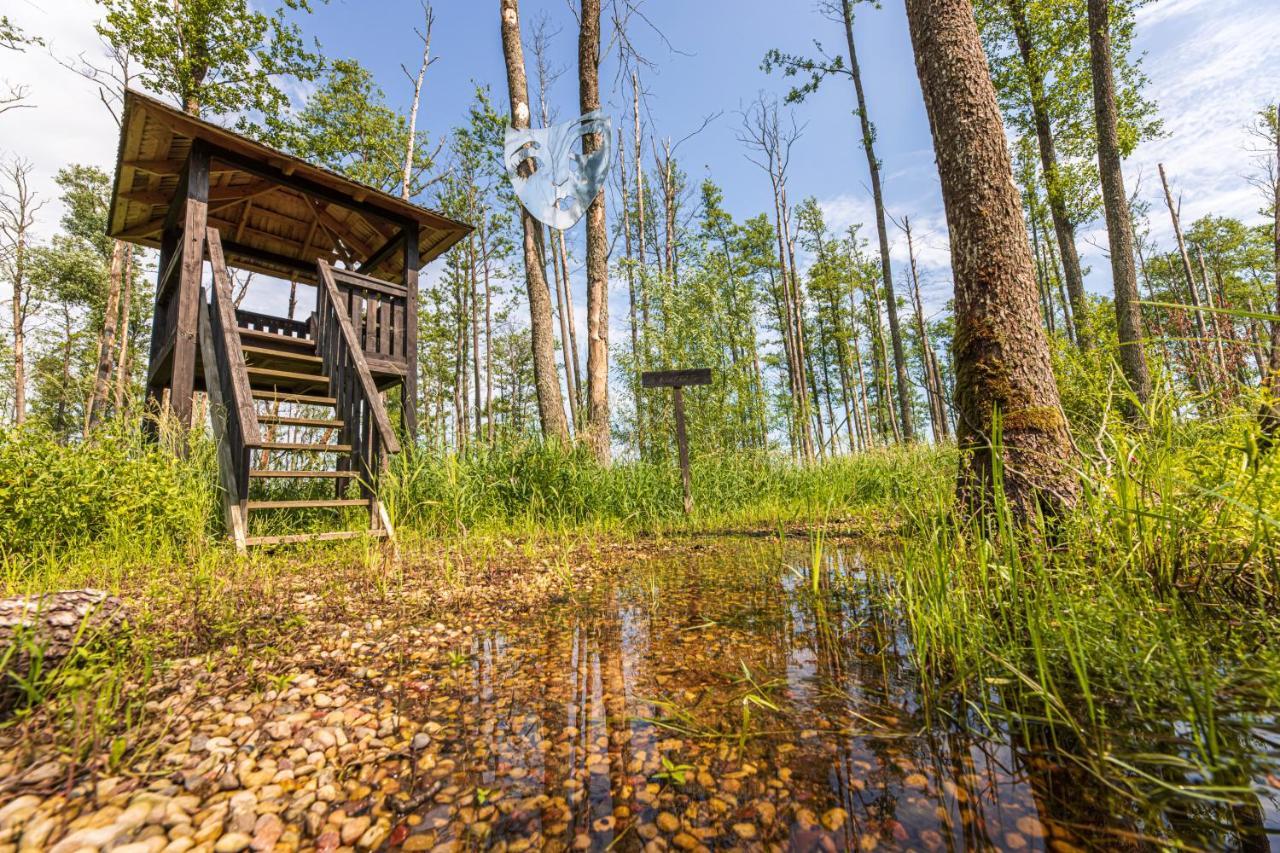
[1007,0,1093,351]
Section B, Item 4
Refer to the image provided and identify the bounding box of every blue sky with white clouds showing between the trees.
[0,0,1280,341]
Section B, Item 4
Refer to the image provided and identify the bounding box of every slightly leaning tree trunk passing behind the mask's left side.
[499,0,568,442]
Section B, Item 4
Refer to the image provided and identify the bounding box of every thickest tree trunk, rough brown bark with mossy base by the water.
[906,0,1080,524]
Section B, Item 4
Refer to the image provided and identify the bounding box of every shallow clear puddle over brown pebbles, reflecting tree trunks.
[389,543,1280,853]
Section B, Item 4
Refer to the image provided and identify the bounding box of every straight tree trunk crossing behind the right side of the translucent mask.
[577,0,611,465]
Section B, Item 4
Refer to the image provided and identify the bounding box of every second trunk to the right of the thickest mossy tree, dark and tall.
[1089,0,1151,419]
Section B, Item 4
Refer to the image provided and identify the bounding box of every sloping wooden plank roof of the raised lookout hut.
[108,90,471,282]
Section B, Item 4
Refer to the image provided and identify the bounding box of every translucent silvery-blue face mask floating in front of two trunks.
[503,110,613,231]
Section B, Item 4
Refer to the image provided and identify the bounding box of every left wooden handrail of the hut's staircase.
[205,228,262,514]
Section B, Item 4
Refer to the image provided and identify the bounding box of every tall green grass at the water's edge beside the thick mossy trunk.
[886,404,1280,800]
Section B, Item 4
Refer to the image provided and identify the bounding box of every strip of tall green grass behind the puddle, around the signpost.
[383,442,950,535]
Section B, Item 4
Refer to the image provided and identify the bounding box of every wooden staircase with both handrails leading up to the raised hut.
[198,228,399,551]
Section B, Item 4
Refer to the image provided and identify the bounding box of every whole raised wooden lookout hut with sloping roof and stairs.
[108,91,470,547]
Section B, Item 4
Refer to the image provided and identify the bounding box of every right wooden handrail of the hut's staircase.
[315,261,399,492]
